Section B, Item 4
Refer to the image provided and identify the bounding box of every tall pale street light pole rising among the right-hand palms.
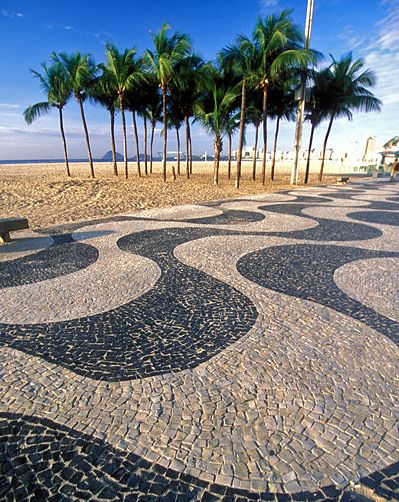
[291,0,314,185]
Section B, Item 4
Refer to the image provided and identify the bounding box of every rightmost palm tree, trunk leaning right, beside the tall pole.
[319,52,382,181]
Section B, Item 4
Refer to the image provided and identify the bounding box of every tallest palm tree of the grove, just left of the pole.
[253,9,316,184]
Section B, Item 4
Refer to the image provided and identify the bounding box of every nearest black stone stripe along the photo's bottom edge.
[0,413,399,502]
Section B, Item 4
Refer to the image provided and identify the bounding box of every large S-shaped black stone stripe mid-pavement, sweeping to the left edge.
[0,228,257,381]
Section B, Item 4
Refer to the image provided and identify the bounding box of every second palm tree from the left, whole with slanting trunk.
[51,52,96,178]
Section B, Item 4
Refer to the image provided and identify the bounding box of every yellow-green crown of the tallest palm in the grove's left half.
[145,24,191,89]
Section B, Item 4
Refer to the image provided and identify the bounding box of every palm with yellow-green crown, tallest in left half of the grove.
[145,24,191,182]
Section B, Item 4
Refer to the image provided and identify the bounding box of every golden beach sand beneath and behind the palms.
[0,162,336,229]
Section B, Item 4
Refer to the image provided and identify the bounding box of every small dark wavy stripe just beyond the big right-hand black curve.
[259,203,382,241]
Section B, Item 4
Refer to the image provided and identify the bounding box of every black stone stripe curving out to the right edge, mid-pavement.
[237,244,399,345]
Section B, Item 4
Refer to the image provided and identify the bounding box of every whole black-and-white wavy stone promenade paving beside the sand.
[0,181,399,501]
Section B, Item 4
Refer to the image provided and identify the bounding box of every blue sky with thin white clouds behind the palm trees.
[0,0,399,159]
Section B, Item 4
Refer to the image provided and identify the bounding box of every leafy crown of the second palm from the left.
[51,52,97,99]
